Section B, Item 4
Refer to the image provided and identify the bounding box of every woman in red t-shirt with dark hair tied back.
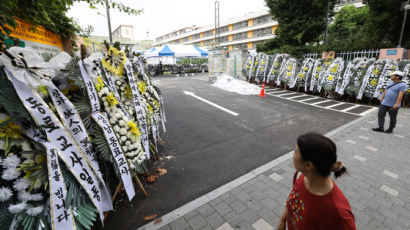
[277,133,356,230]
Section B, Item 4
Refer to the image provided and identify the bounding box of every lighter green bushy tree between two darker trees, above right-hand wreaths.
[326,5,371,51]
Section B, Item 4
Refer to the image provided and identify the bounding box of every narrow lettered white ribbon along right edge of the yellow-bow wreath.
[125,60,150,159]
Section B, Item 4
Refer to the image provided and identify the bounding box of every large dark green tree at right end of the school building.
[265,0,336,55]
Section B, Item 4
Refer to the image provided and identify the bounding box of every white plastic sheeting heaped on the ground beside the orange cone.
[213,75,260,95]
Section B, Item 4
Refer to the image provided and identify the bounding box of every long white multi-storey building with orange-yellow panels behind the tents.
[154,10,278,50]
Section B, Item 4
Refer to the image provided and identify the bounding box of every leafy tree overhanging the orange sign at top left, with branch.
[0,0,142,48]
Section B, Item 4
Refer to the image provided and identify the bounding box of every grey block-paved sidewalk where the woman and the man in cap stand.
[139,109,410,230]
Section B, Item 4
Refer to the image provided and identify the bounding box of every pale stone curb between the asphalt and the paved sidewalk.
[138,113,373,230]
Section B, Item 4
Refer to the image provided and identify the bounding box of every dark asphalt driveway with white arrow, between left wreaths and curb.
[104,75,358,230]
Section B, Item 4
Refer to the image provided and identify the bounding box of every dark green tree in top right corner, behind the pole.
[363,0,410,48]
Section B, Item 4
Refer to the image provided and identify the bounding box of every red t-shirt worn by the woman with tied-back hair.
[286,172,356,230]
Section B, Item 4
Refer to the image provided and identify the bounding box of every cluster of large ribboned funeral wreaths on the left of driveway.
[0,47,165,230]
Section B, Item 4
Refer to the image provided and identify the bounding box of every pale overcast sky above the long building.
[67,0,267,40]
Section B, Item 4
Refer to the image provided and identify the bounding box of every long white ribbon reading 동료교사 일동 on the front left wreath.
[5,69,104,221]
